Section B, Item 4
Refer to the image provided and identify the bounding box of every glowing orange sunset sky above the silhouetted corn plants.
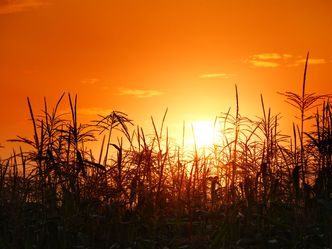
[0,0,332,156]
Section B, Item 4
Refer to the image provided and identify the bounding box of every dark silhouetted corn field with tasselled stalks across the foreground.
[0,58,332,249]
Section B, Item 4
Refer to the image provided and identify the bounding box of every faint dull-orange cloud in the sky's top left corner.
[0,0,50,14]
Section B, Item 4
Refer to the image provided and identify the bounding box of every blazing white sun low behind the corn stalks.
[187,120,221,149]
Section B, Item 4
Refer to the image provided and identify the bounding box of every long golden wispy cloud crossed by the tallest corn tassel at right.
[244,53,327,68]
